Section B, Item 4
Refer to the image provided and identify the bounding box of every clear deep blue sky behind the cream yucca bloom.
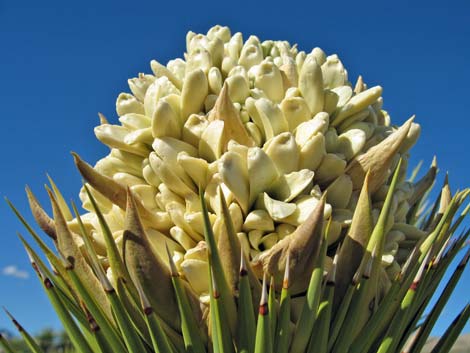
[0,0,470,333]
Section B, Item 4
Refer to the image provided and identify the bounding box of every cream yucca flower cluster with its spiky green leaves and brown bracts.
[0,26,469,353]
